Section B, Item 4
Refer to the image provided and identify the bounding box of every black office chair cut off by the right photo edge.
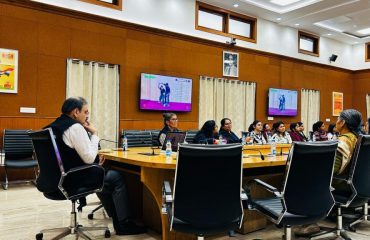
[312,135,370,240]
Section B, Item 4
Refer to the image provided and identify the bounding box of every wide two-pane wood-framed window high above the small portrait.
[195,2,257,43]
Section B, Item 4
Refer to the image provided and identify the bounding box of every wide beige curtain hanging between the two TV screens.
[199,76,256,136]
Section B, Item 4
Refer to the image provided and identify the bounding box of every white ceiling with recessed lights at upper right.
[200,0,370,44]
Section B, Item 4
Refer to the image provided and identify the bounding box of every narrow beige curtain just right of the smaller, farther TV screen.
[301,89,320,136]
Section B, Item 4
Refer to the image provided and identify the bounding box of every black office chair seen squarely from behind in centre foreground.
[163,144,243,239]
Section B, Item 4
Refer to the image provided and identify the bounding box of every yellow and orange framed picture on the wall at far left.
[0,48,18,93]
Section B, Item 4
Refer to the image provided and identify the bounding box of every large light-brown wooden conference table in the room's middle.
[100,144,290,240]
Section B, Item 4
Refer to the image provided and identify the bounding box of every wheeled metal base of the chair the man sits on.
[36,201,111,240]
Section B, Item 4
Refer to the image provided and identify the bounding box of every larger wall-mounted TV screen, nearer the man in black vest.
[140,73,192,112]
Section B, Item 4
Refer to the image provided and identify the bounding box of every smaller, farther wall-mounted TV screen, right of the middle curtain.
[268,88,298,116]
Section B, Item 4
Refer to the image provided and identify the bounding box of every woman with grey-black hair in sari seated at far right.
[295,109,362,236]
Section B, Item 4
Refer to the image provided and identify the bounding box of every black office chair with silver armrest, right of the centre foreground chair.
[247,142,337,239]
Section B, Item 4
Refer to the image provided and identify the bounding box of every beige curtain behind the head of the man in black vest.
[66,59,119,148]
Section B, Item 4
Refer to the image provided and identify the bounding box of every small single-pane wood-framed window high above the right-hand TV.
[298,31,320,57]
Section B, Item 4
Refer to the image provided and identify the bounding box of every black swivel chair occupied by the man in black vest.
[30,128,110,240]
